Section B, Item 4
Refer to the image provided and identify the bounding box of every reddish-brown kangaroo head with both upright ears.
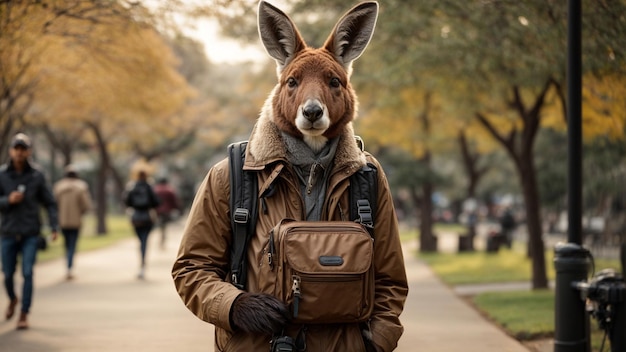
[258,1,378,151]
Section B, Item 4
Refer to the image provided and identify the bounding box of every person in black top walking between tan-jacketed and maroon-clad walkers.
[124,171,160,280]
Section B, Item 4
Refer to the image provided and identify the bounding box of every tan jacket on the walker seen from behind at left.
[52,177,91,229]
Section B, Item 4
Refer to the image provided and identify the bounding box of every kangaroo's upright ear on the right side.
[324,1,378,72]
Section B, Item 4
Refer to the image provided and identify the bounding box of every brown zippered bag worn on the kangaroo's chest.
[281,222,374,323]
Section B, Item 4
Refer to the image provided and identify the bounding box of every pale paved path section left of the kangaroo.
[0,223,213,352]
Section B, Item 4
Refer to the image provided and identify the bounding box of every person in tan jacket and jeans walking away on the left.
[52,165,91,280]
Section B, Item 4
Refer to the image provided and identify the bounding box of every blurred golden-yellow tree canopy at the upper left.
[0,0,196,153]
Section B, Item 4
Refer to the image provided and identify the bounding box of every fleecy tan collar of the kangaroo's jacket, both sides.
[244,104,366,174]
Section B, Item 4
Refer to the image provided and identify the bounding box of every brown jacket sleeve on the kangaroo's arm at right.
[370,157,409,352]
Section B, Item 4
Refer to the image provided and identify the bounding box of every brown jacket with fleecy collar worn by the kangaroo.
[172,117,408,352]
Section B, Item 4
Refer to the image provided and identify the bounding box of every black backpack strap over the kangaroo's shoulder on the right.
[350,163,378,238]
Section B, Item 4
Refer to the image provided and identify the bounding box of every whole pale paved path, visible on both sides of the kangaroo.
[0,221,528,352]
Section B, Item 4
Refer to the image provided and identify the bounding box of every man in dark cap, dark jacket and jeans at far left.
[0,133,58,330]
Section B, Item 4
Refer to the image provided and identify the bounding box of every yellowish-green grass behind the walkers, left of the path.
[37,215,134,262]
